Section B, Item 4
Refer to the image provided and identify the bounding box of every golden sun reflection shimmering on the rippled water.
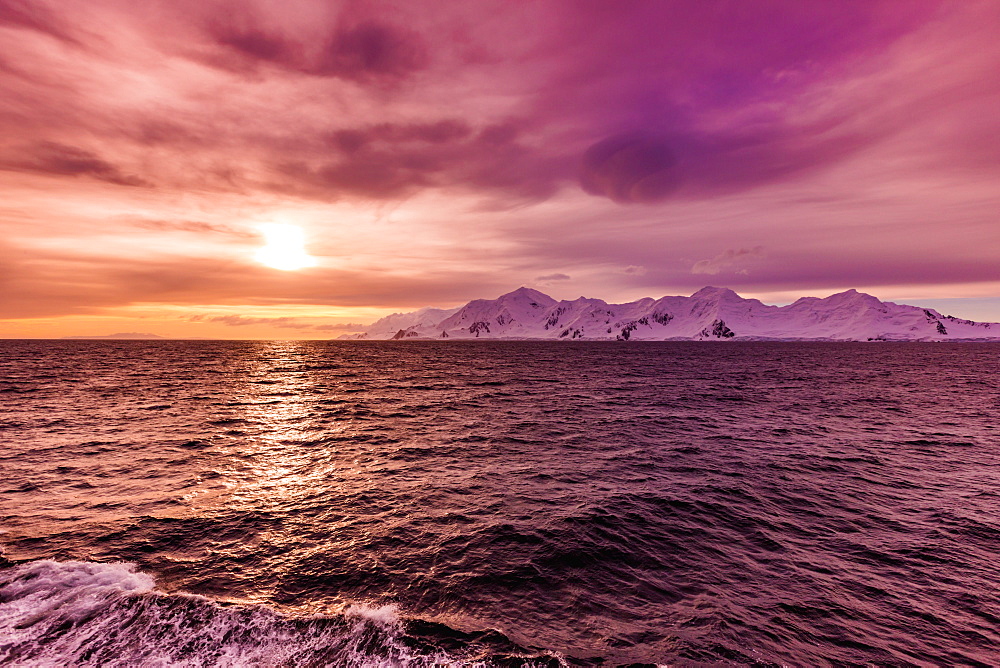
[174,341,370,613]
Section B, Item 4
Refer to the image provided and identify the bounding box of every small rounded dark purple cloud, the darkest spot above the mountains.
[580,133,679,203]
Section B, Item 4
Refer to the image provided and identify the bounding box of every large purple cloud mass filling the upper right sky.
[537,0,939,203]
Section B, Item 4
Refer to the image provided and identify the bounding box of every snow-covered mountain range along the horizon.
[344,287,1000,341]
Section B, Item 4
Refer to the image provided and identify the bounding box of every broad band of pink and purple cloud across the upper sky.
[0,0,936,208]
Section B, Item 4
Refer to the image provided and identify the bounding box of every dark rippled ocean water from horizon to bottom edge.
[0,341,1000,666]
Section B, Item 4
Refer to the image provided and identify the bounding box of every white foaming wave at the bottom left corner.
[0,560,566,668]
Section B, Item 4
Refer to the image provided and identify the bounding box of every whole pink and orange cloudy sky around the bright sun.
[0,0,1000,338]
